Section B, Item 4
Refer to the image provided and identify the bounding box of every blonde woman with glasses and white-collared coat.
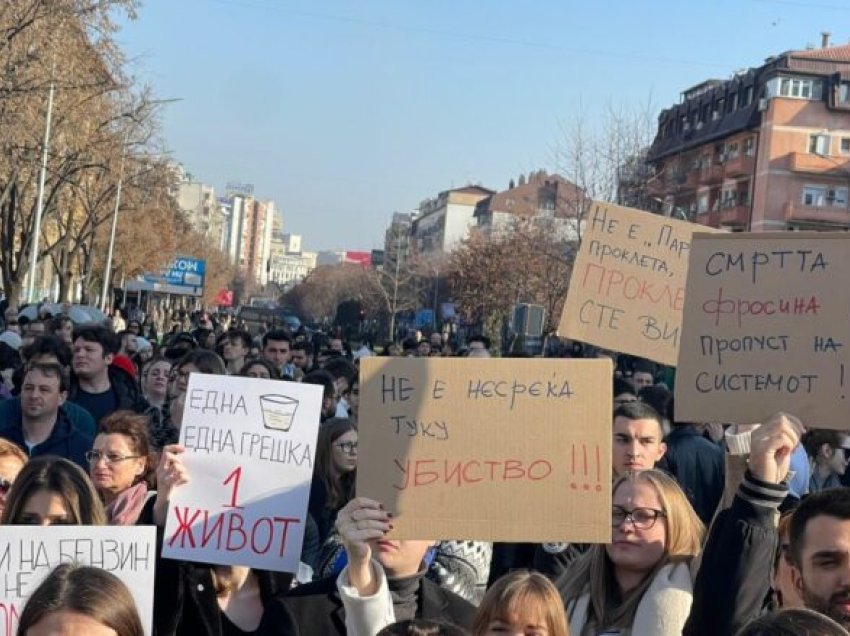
[558,470,705,636]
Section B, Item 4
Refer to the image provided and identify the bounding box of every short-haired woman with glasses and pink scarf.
[86,411,152,526]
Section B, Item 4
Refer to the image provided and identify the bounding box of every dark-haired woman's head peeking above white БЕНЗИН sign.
[0,456,107,526]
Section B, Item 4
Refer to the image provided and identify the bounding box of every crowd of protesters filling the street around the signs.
[0,300,850,636]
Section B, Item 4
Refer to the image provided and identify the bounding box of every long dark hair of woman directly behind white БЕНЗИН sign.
[0,455,106,526]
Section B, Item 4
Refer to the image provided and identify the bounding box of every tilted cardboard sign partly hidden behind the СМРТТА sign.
[558,202,711,365]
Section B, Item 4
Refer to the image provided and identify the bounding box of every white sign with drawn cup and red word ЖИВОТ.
[162,373,322,572]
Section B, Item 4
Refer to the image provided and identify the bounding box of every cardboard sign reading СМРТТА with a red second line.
[675,232,850,429]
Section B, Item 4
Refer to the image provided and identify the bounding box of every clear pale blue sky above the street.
[119,0,850,250]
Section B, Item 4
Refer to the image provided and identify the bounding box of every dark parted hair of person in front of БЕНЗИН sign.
[17,563,144,636]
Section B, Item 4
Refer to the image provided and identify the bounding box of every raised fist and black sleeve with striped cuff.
[682,413,800,636]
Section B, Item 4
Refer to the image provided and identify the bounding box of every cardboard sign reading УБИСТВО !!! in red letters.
[357,358,612,542]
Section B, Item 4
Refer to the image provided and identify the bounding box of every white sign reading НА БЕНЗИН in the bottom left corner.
[0,526,156,635]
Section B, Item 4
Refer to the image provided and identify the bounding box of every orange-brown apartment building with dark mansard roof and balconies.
[647,34,850,232]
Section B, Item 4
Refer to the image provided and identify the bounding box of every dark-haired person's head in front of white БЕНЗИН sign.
[17,563,144,636]
